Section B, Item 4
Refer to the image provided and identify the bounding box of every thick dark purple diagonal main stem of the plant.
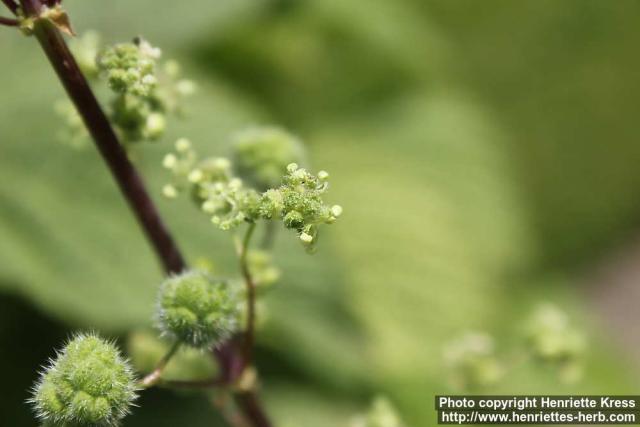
[21,5,271,427]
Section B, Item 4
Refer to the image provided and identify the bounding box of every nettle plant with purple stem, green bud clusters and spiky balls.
[0,0,344,427]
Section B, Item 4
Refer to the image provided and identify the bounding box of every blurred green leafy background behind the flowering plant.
[0,0,640,427]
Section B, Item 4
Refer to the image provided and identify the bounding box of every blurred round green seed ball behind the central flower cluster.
[232,127,304,191]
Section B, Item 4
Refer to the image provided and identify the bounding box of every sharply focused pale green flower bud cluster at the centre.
[162,135,342,250]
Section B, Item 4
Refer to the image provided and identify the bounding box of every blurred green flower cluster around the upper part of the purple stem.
[56,31,195,146]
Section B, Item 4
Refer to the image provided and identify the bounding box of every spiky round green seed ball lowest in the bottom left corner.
[31,334,136,427]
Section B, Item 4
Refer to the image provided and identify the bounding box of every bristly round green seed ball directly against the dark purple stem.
[157,271,238,348]
